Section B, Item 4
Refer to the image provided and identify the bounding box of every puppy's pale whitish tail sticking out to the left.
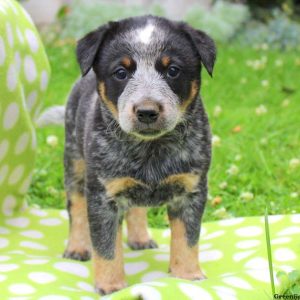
[36,105,66,128]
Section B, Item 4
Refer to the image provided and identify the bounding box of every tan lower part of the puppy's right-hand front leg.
[170,219,205,280]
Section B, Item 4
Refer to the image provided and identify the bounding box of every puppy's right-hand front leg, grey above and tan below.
[168,186,206,280]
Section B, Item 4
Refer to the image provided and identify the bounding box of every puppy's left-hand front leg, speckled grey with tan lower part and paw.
[87,185,126,294]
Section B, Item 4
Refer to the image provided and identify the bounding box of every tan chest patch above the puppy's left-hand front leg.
[104,177,145,197]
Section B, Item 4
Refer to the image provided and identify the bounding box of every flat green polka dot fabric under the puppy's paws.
[0,208,300,300]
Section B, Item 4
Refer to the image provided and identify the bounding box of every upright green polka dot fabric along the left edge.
[0,0,50,216]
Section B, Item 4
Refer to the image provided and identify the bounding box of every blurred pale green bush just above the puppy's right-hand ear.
[185,1,250,42]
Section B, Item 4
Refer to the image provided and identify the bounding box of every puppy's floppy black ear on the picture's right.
[183,23,217,76]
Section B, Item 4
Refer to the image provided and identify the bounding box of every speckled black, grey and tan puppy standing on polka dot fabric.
[64,16,216,294]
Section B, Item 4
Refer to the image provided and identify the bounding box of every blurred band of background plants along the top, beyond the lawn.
[29,0,300,49]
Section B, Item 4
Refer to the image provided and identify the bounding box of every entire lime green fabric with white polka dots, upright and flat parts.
[0,0,300,300]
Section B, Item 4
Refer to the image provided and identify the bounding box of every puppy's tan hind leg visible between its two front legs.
[126,207,157,250]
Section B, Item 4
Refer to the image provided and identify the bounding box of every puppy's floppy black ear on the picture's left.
[76,22,116,76]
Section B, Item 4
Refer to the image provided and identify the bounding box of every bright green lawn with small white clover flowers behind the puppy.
[29,45,300,227]
